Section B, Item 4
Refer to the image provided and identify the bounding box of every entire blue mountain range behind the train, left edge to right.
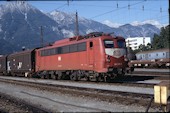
[0,1,160,54]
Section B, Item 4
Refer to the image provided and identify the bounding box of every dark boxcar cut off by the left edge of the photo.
[0,56,7,75]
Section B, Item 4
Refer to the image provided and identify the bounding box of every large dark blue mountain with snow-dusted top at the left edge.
[0,2,63,54]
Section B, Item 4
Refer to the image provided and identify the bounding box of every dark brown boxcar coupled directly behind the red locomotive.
[7,49,35,76]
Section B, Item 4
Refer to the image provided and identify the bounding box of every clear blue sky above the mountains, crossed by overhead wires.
[0,0,169,26]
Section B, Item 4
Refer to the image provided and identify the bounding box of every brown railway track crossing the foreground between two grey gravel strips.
[0,75,162,109]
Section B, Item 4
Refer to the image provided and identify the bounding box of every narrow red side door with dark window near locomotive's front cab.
[88,41,94,67]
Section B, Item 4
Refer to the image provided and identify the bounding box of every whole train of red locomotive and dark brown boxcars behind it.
[0,32,127,81]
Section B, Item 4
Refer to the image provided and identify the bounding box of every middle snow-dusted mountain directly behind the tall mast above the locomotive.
[47,10,113,37]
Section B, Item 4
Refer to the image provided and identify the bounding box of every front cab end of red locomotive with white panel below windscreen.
[103,37,127,77]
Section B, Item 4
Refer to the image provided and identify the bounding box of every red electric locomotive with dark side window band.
[35,32,127,81]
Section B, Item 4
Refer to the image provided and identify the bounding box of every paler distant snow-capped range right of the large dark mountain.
[47,10,160,38]
